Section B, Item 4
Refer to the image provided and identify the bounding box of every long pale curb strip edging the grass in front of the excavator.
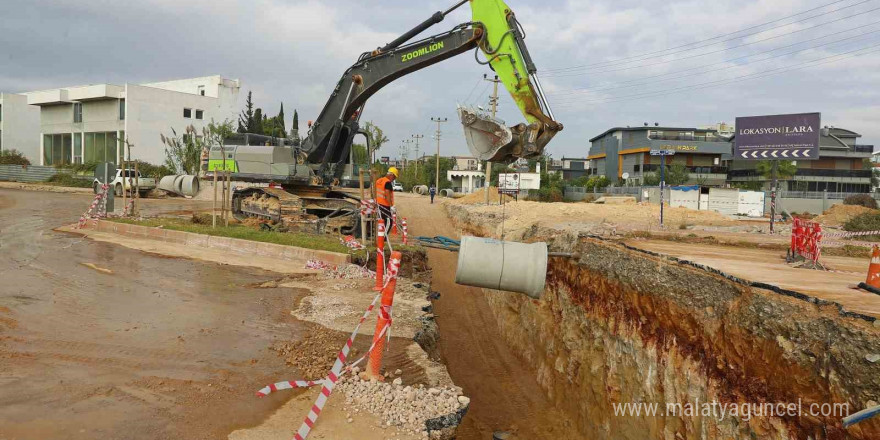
[87,220,351,264]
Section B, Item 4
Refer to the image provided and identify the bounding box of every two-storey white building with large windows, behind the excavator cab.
[27,75,241,165]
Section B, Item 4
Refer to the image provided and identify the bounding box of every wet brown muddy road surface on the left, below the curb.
[0,189,304,439]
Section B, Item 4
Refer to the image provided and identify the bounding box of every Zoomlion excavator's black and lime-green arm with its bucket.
[298,0,562,184]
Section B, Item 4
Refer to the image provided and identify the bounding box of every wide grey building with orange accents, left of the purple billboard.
[587,125,731,185]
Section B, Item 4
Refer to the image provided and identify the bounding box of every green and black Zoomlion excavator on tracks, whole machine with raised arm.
[208,0,563,235]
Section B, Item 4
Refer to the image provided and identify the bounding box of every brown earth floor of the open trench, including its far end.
[396,194,580,440]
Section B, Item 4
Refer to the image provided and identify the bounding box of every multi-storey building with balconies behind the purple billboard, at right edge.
[729,127,874,192]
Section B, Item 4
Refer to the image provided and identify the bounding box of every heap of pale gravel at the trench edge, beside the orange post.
[336,367,470,439]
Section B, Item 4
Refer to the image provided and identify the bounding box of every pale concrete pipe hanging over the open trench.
[455,237,547,299]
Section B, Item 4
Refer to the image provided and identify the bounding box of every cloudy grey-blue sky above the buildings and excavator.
[0,0,880,158]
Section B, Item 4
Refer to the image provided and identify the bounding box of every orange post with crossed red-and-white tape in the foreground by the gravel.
[257,252,400,440]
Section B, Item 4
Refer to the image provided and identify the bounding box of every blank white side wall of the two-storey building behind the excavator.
[125,84,239,164]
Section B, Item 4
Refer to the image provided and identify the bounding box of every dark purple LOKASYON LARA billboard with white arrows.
[733,113,821,160]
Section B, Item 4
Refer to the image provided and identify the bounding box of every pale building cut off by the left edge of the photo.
[0,93,40,163]
